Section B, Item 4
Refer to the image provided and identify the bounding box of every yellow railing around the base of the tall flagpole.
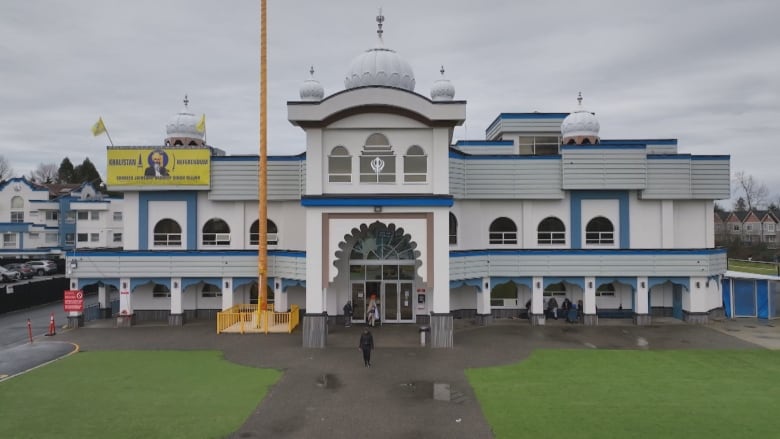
[217,303,300,334]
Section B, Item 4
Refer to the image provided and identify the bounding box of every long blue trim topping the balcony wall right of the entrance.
[450,248,726,258]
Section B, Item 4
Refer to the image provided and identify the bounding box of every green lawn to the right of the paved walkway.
[466,350,780,439]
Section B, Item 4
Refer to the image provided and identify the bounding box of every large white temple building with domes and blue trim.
[69,12,730,347]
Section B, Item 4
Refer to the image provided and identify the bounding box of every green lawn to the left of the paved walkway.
[0,351,281,439]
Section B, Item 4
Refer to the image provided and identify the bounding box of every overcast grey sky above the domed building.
[0,0,780,206]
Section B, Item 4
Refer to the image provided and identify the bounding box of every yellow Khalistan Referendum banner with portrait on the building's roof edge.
[106,147,211,186]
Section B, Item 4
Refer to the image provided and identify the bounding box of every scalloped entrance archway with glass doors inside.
[336,221,422,323]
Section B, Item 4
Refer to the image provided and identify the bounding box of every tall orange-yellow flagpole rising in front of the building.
[257,0,268,314]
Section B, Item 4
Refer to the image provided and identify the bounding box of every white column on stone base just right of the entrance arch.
[432,208,450,314]
